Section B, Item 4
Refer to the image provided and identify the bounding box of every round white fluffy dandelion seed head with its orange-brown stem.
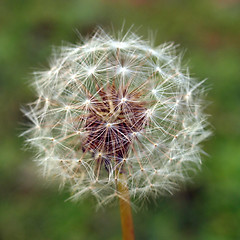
[24,29,209,239]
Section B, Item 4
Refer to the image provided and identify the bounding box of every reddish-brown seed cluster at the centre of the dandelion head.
[82,85,147,172]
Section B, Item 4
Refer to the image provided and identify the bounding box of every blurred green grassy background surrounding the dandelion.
[0,0,240,240]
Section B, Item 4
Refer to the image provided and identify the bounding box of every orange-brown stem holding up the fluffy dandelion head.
[117,173,135,240]
